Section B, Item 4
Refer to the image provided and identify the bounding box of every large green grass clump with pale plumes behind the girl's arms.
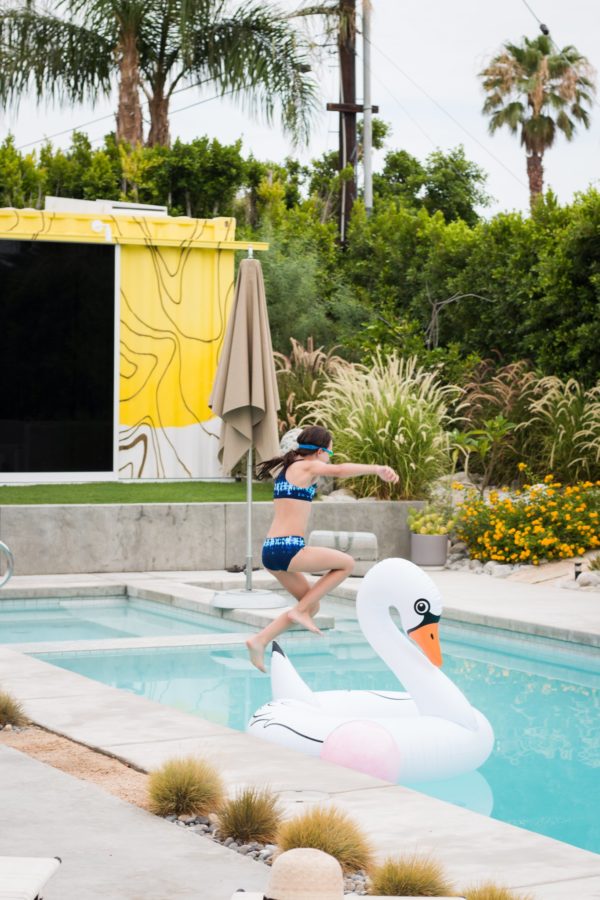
[304,353,458,500]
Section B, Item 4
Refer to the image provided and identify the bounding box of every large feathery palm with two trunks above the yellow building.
[0,0,316,146]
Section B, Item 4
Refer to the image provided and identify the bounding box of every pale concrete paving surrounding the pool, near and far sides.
[0,571,600,900]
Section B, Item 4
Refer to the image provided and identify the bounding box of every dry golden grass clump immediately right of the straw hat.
[369,854,454,897]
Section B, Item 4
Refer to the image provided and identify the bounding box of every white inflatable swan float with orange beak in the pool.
[247,559,494,782]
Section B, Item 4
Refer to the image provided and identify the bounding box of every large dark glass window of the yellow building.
[0,240,115,472]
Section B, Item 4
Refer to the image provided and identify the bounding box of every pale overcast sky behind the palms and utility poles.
[0,0,600,214]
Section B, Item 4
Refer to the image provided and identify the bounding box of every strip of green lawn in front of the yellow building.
[0,481,273,506]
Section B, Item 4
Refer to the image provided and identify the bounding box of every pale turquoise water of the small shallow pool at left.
[0,596,245,644]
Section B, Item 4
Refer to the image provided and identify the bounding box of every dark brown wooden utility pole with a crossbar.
[327,0,379,245]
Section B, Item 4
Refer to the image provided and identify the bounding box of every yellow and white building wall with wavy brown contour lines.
[0,207,264,478]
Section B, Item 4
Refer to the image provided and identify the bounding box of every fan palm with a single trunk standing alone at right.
[479,35,595,205]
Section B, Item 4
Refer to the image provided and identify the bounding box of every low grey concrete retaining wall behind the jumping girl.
[0,500,420,575]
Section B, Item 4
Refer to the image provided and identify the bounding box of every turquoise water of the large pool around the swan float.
[40,619,600,852]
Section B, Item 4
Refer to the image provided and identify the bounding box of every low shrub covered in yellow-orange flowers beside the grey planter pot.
[456,475,600,565]
